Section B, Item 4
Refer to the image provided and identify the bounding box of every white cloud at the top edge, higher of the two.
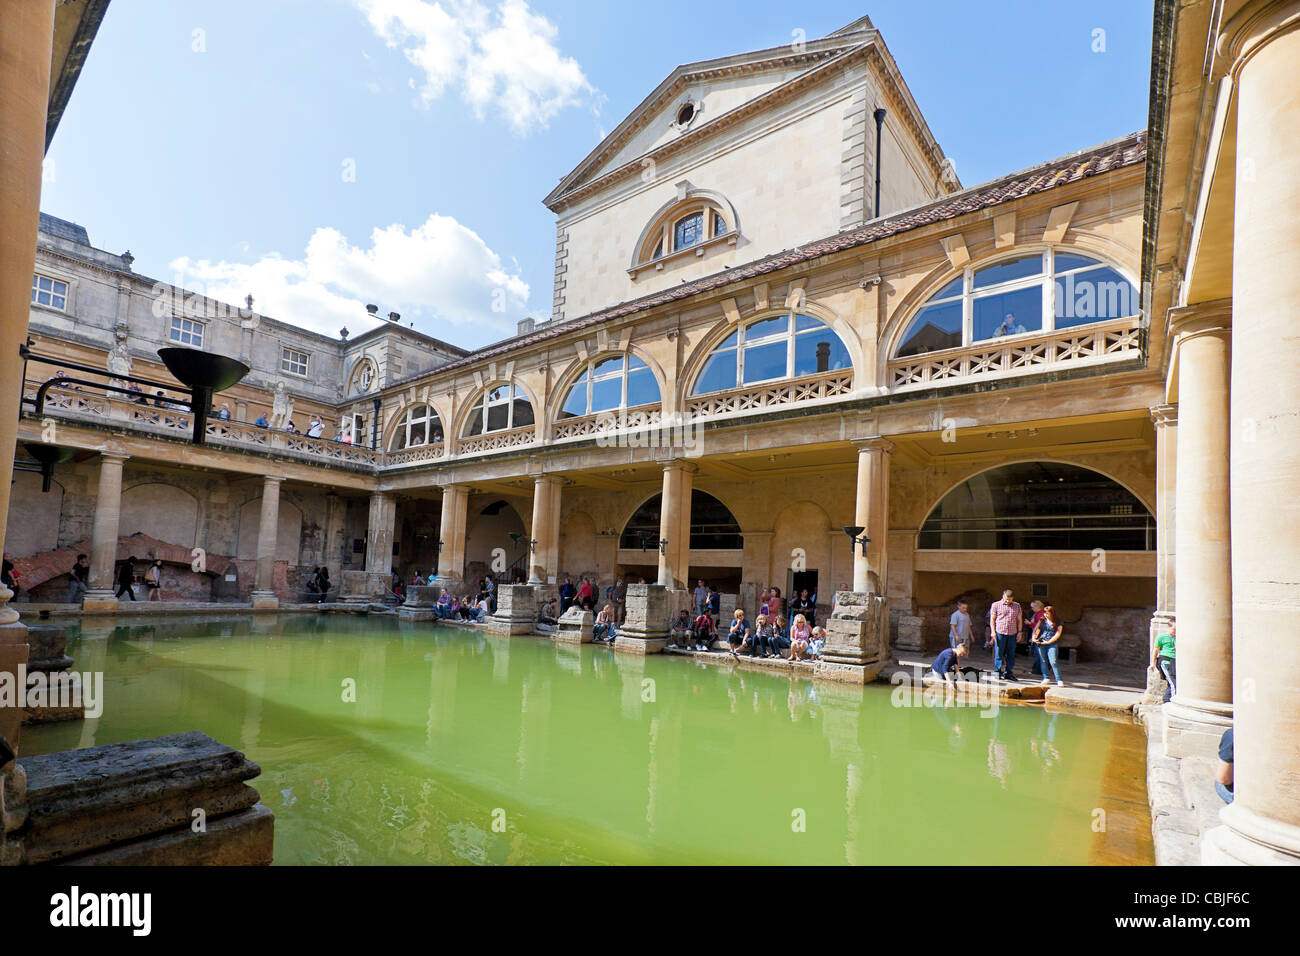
[355,0,601,135]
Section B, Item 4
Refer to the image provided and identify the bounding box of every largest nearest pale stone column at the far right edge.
[1201,0,1300,864]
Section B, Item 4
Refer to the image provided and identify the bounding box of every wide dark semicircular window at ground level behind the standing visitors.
[918,462,1156,551]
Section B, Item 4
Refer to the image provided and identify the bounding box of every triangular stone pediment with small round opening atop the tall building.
[545,17,878,206]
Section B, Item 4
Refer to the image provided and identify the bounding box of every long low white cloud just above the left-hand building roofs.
[170,215,528,345]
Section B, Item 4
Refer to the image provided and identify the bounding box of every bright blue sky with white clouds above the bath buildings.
[42,0,1152,347]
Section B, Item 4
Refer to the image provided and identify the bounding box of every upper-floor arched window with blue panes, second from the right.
[692,312,853,395]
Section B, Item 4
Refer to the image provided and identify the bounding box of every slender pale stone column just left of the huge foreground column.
[1165,302,1232,757]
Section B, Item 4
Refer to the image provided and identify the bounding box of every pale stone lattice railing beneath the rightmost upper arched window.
[888,316,1141,392]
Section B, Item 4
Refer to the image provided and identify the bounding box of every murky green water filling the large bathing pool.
[22,615,1151,864]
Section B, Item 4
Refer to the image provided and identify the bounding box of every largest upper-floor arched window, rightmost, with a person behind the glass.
[894,248,1141,358]
